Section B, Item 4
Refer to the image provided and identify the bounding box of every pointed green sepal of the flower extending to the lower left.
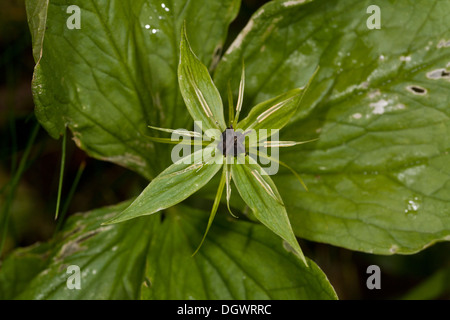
[108,147,222,223]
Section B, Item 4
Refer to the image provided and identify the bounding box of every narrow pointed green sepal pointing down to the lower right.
[231,164,306,264]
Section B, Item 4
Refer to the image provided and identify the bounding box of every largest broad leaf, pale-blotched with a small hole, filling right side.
[214,0,450,254]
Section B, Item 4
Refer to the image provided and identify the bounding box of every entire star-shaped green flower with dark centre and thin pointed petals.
[107,26,313,264]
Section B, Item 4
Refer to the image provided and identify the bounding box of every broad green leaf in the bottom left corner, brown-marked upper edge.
[0,203,152,299]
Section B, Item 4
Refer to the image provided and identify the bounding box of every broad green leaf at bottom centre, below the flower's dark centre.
[142,206,336,299]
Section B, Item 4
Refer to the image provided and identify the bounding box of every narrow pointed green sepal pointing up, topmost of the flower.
[178,26,226,132]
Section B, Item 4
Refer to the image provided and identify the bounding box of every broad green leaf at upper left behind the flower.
[27,0,240,178]
